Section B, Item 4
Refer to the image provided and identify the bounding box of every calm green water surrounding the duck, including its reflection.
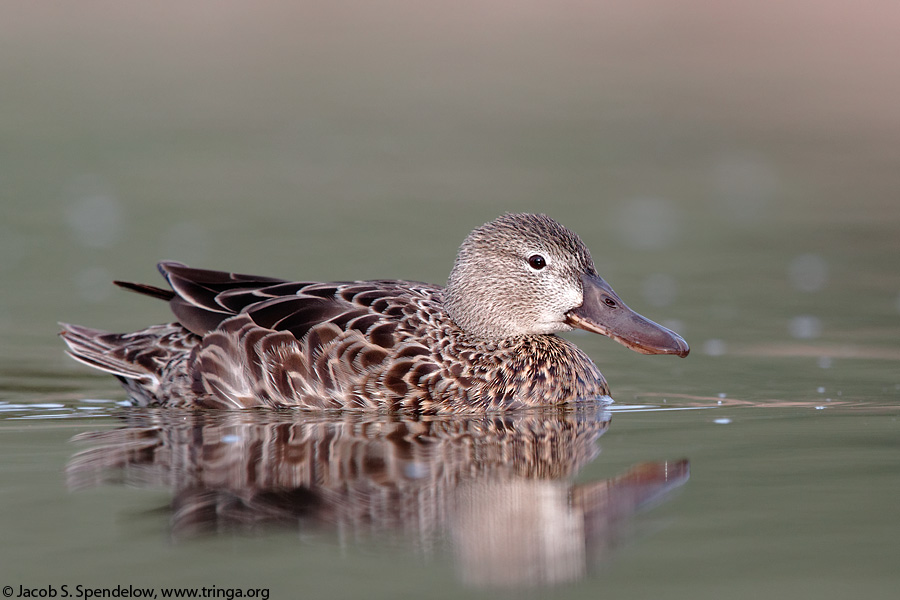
[0,1,900,598]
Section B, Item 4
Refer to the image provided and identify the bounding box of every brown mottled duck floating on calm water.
[60,213,690,414]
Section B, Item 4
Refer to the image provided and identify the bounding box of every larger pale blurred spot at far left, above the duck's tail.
[63,177,124,248]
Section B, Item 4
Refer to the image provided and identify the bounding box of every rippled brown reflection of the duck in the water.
[67,405,687,585]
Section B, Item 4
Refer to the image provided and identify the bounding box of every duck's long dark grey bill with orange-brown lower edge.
[566,275,691,357]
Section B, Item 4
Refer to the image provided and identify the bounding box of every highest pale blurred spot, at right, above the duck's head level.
[712,153,779,225]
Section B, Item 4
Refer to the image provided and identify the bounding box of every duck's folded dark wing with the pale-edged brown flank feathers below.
[161,263,448,408]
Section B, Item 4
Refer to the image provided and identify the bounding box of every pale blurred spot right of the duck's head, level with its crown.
[613,197,681,250]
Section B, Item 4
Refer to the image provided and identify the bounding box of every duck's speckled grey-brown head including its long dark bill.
[444,214,689,356]
